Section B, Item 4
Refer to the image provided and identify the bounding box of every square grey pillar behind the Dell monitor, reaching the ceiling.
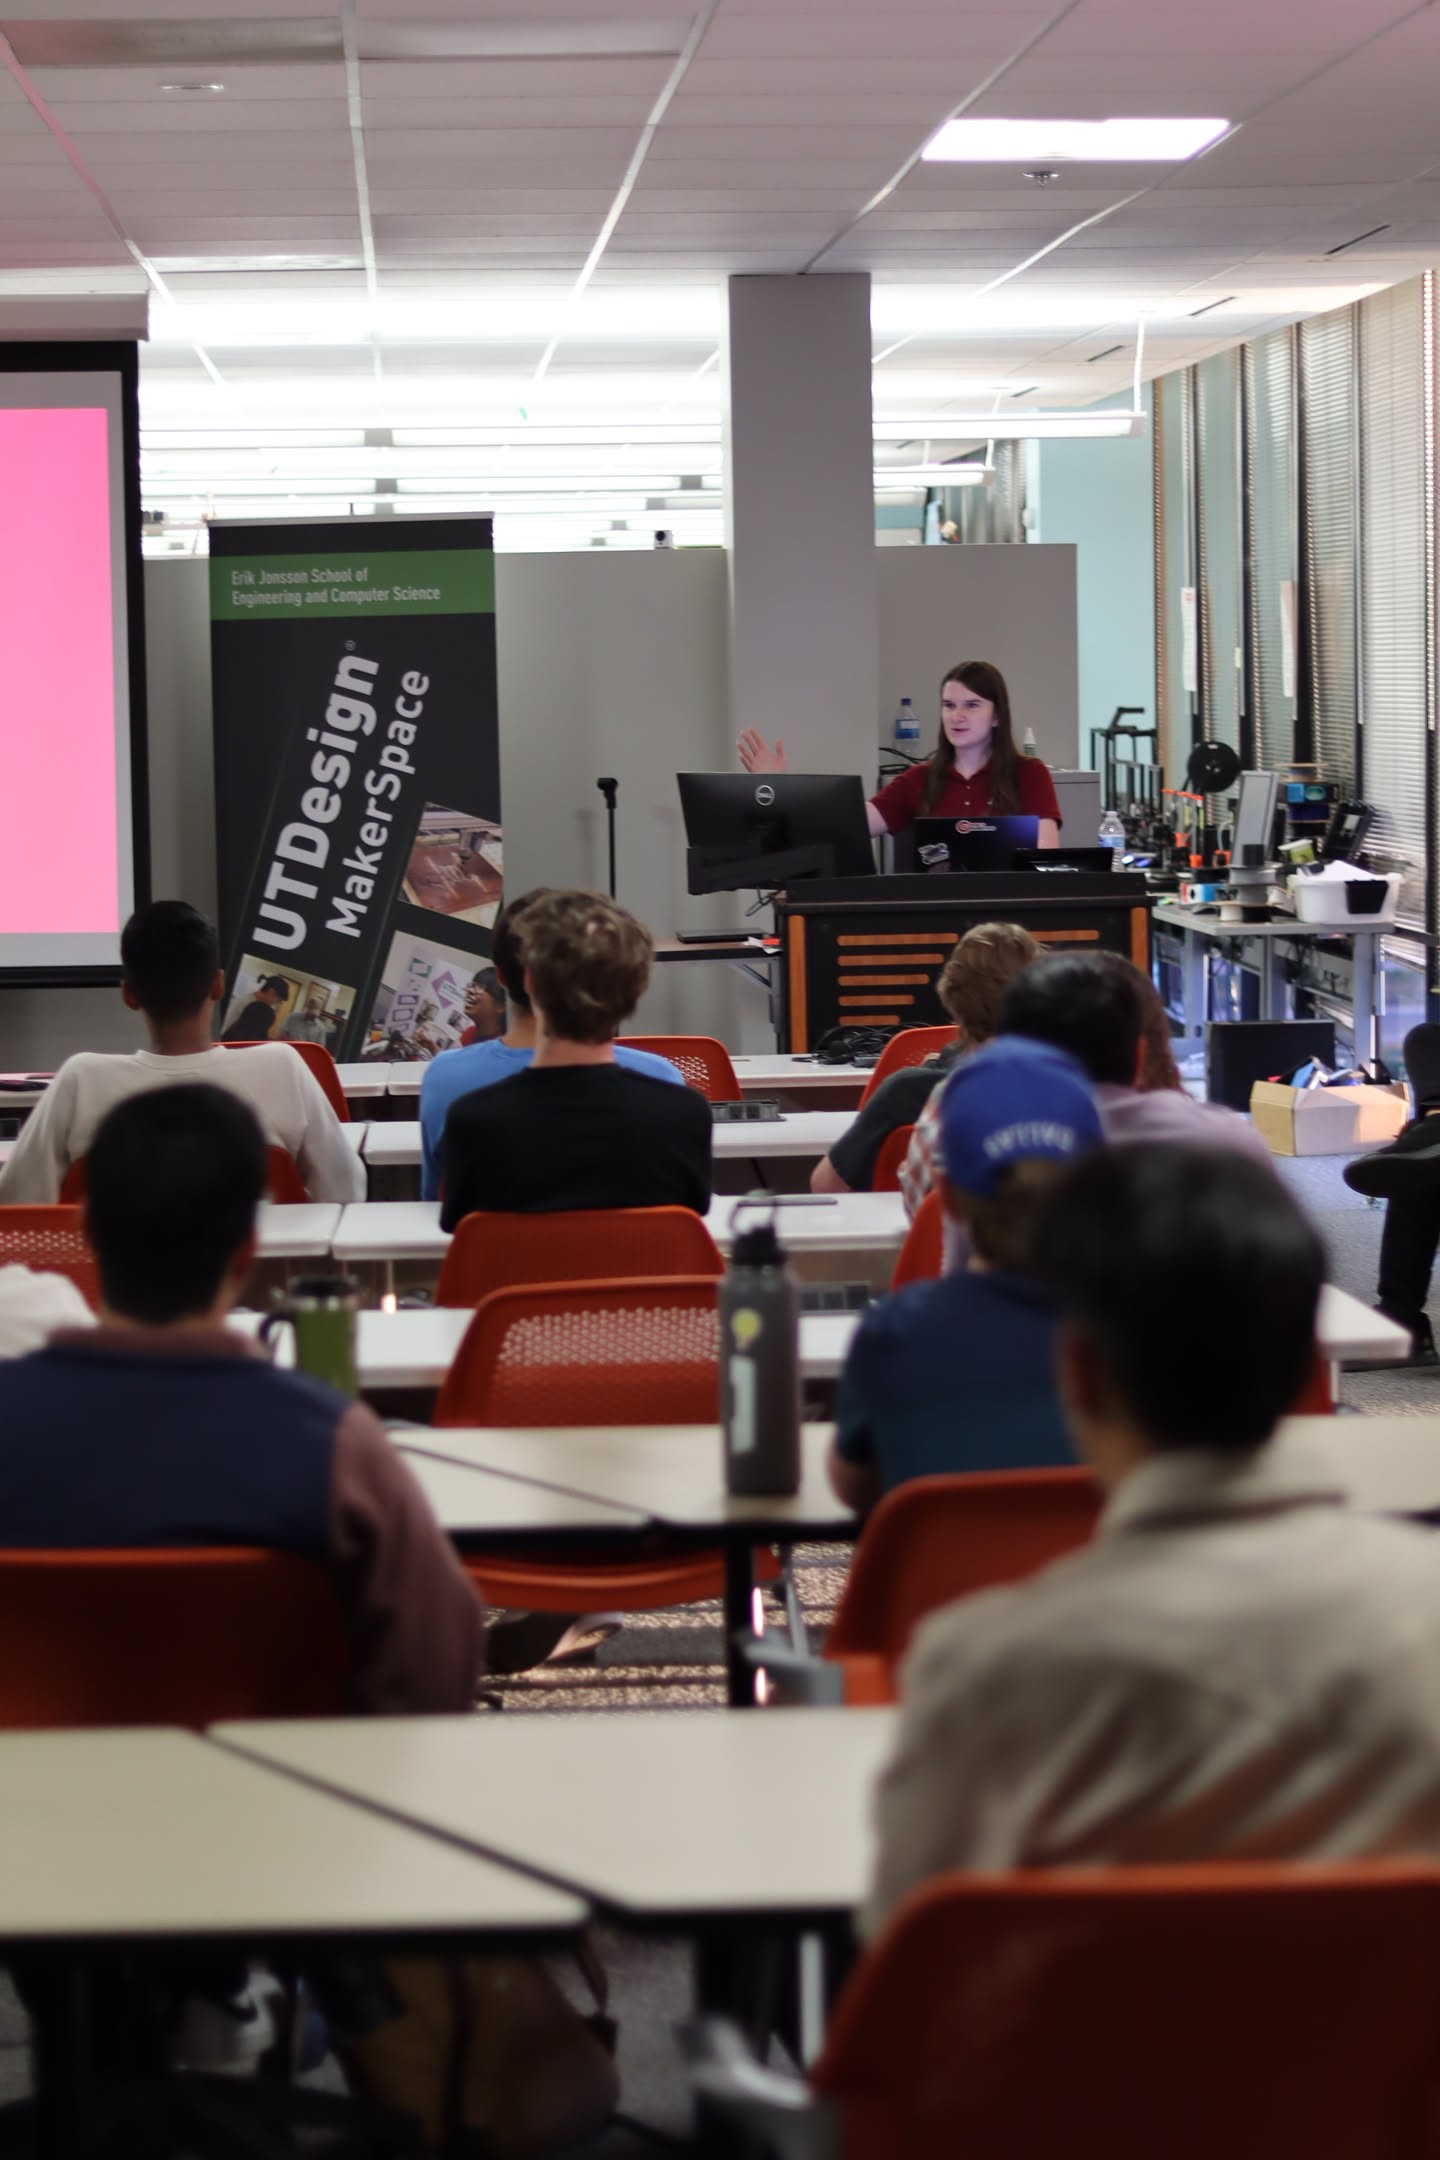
[725,272,879,793]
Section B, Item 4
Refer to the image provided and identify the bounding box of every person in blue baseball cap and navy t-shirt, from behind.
[829,1041,1101,1508]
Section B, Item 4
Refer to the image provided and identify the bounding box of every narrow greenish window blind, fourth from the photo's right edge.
[1194,352,1241,750]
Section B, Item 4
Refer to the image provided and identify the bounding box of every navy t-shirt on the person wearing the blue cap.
[836,1272,1075,1493]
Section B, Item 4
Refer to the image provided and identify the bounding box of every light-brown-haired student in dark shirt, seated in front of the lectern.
[810,922,1041,1192]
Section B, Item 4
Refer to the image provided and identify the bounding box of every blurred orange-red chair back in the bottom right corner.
[812,1862,1440,2160]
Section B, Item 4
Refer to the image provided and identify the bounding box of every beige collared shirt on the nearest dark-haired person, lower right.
[861,1439,1440,1931]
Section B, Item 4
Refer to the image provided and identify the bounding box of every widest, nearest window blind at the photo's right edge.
[1360,279,1427,929]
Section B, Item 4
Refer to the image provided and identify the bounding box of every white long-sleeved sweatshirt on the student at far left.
[0,1043,365,1207]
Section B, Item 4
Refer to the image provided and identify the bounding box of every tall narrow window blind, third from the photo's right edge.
[1244,330,1298,769]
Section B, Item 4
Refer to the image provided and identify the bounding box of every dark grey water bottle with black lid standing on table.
[719,1201,801,1495]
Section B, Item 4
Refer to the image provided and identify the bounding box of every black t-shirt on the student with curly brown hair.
[440,1065,712,1229]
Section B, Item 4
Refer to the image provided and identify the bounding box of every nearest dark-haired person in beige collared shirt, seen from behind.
[866,1145,1440,1929]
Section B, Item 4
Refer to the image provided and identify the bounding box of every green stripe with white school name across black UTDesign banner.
[209,546,494,622]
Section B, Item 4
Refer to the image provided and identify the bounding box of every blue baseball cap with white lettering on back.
[939,1035,1101,1199]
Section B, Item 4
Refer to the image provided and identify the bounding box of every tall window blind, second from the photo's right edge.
[1300,307,1360,795]
